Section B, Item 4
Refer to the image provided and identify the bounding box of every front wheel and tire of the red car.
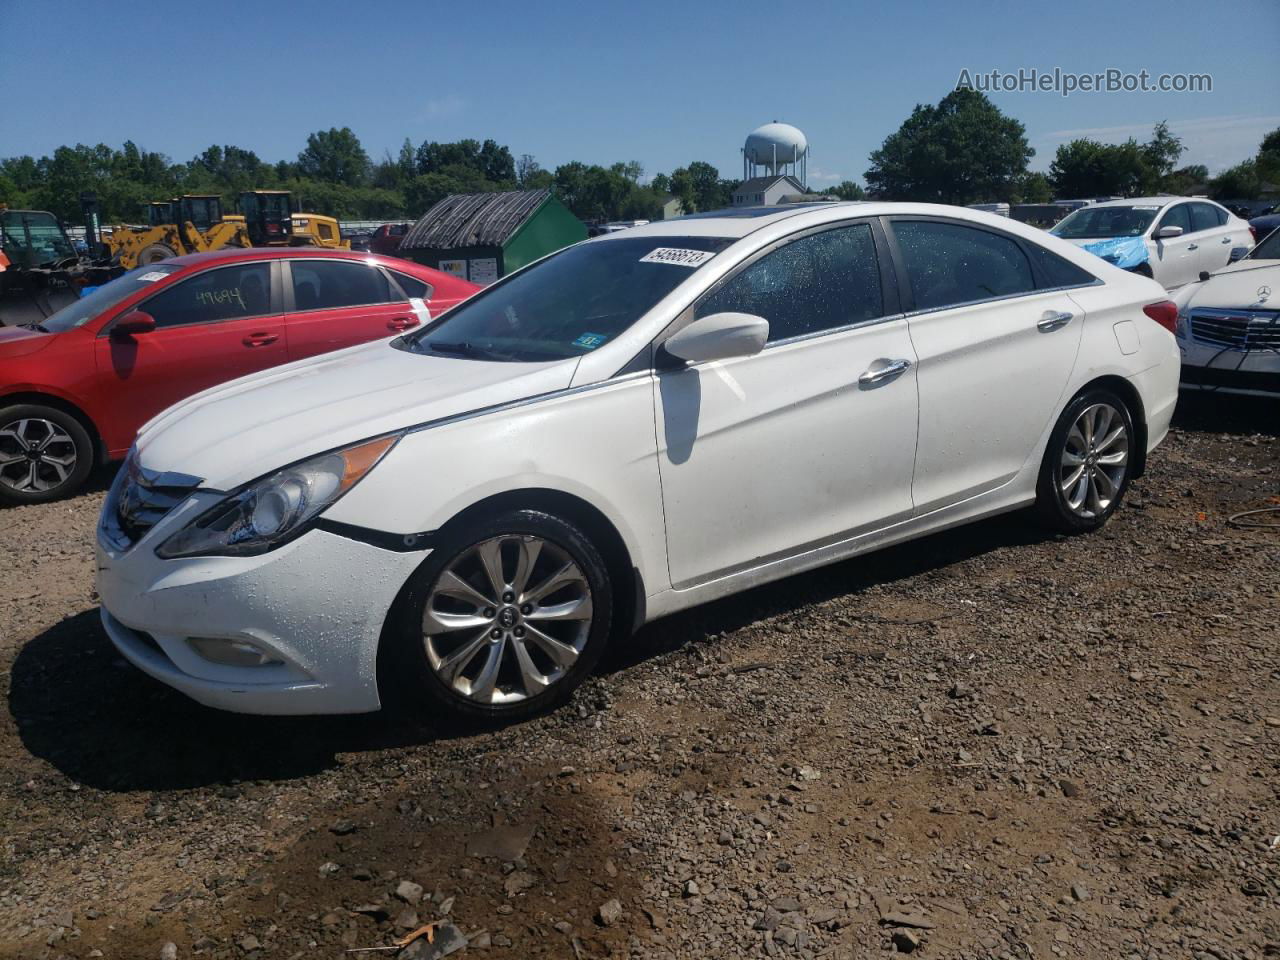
[0,403,93,506]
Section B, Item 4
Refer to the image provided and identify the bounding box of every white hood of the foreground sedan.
[137,340,577,490]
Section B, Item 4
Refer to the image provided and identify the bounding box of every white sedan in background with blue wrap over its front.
[1051,197,1253,289]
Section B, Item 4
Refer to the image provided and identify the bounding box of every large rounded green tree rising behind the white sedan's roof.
[867,88,1036,204]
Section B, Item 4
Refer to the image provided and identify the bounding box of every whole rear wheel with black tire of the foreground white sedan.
[1036,387,1137,534]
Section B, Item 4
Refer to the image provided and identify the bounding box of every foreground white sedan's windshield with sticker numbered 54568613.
[402,237,733,362]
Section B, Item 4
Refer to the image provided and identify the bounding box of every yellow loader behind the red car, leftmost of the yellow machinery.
[102,193,253,270]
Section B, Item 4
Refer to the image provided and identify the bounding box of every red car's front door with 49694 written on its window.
[95,264,288,447]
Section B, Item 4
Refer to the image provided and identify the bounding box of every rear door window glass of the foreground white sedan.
[893,220,1036,310]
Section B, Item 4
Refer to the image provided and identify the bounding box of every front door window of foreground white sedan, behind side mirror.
[695,224,884,343]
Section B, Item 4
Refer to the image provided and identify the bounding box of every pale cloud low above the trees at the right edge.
[1032,114,1280,174]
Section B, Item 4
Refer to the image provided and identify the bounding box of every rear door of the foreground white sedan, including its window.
[892,220,1084,513]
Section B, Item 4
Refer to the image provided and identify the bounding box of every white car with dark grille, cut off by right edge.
[1174,230,1280,397]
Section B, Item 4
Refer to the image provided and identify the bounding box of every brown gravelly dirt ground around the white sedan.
[0,398,1280,960]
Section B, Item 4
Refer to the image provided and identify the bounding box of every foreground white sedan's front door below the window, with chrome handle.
[655,325,916,586]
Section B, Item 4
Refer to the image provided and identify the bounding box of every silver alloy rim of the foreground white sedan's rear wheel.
[1059,403,1129,520]
